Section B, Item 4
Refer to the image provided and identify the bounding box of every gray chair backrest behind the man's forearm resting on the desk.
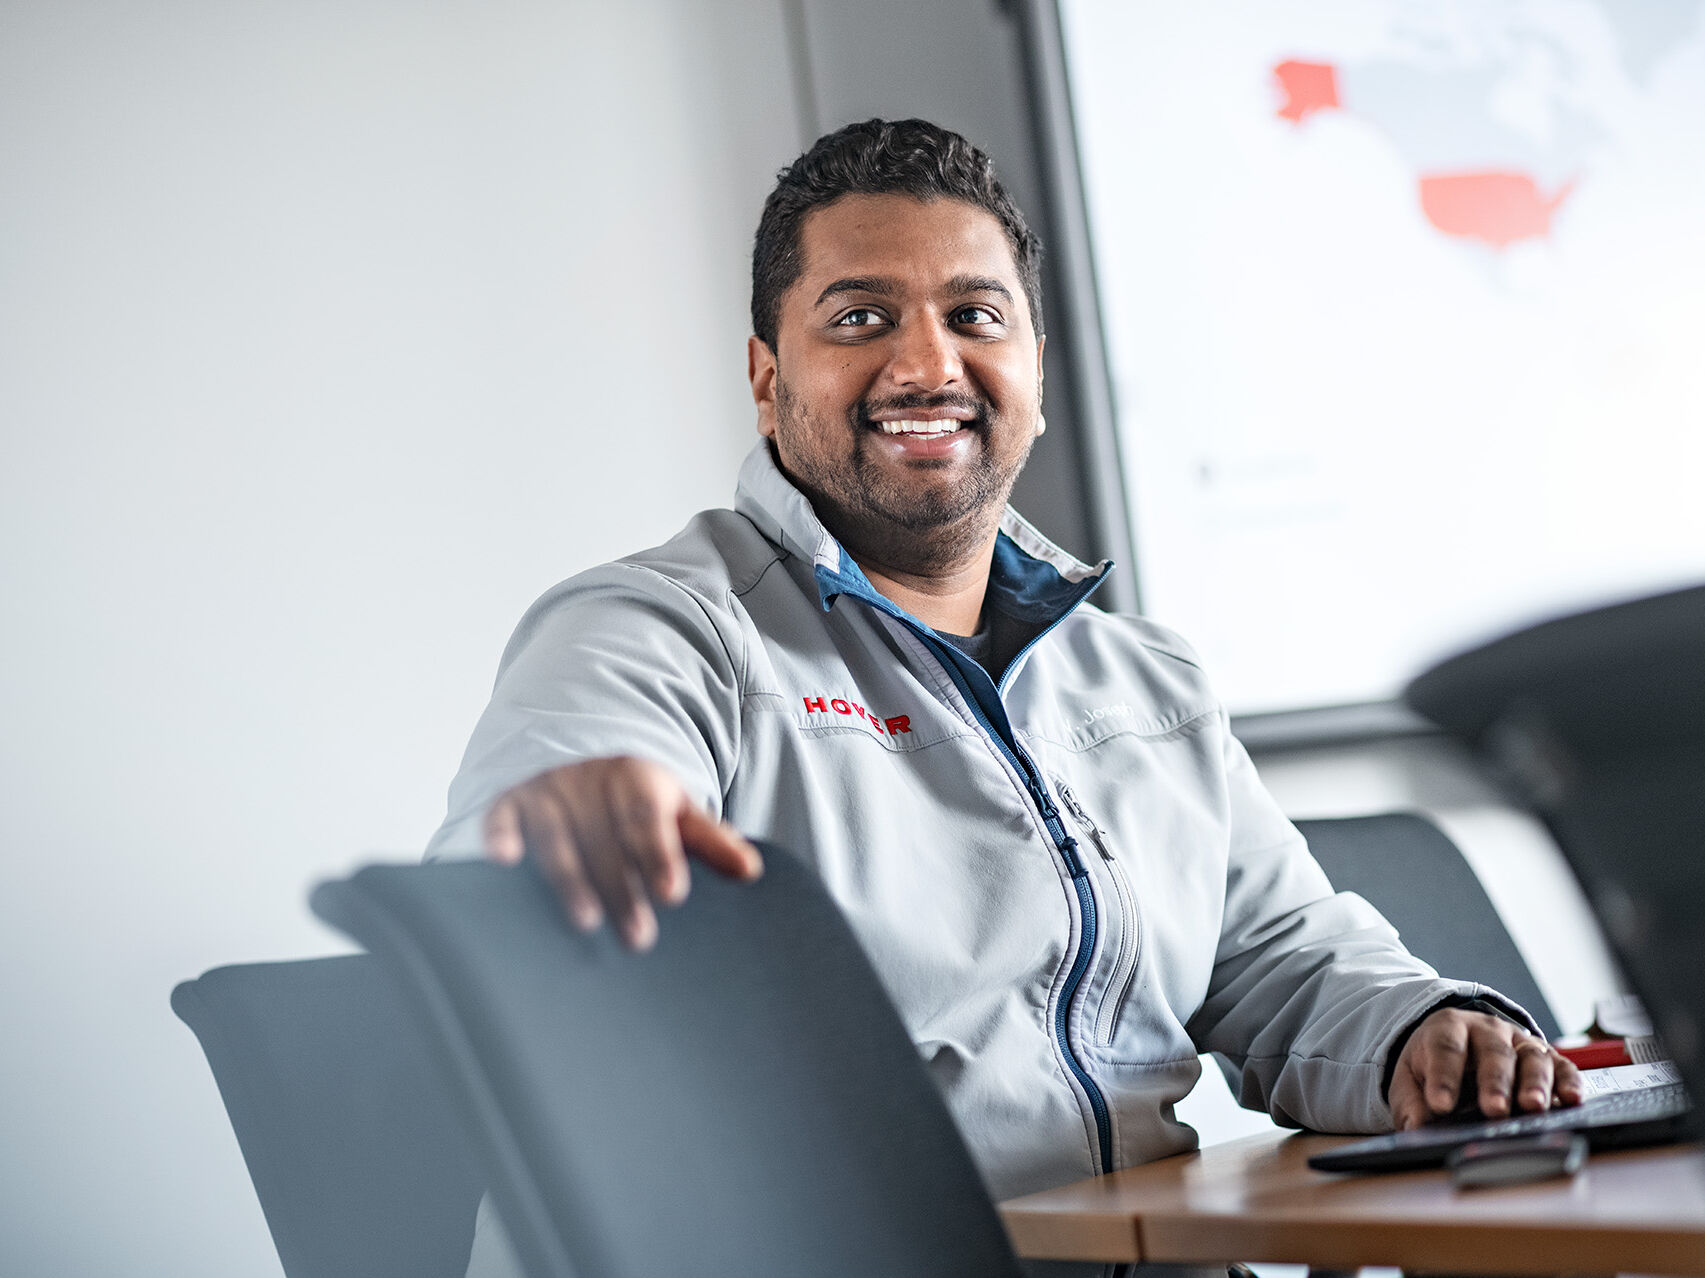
[1296,813,1558,1038]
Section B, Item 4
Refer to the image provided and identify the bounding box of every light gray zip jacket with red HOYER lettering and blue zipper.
[430,443,1519,1198]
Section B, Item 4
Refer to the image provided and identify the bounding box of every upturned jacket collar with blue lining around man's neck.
[735,440,1113,622]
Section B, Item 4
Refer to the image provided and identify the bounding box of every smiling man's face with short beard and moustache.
[748,194,1042,571]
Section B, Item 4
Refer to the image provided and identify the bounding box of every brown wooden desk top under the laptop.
[1001,1133,1705,1275]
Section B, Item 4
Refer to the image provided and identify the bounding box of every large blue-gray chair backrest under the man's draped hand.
[312,849,1018,1278]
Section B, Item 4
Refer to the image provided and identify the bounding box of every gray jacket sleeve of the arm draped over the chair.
[426,562,740,857]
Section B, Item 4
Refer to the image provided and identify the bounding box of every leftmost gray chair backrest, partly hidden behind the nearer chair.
[172,954,484,1278]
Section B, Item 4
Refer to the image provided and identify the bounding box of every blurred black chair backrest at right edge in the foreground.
[1403,586,1705,1113]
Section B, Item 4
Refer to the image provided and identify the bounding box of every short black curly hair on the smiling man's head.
[752,119,1042,351]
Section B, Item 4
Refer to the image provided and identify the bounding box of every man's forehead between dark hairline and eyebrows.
[789,194,1023,307]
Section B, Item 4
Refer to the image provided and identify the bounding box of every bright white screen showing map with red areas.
[1061,0,1705,712]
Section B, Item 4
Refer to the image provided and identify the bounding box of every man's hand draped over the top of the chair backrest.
[486,758,764,949]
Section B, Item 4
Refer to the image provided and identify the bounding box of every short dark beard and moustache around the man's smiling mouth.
[774,377,1035,574]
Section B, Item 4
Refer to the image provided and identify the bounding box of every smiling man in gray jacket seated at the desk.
[435,121,1581,1278]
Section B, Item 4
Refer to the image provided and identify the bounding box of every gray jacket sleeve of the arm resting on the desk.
[1188,731,1538,1131]
